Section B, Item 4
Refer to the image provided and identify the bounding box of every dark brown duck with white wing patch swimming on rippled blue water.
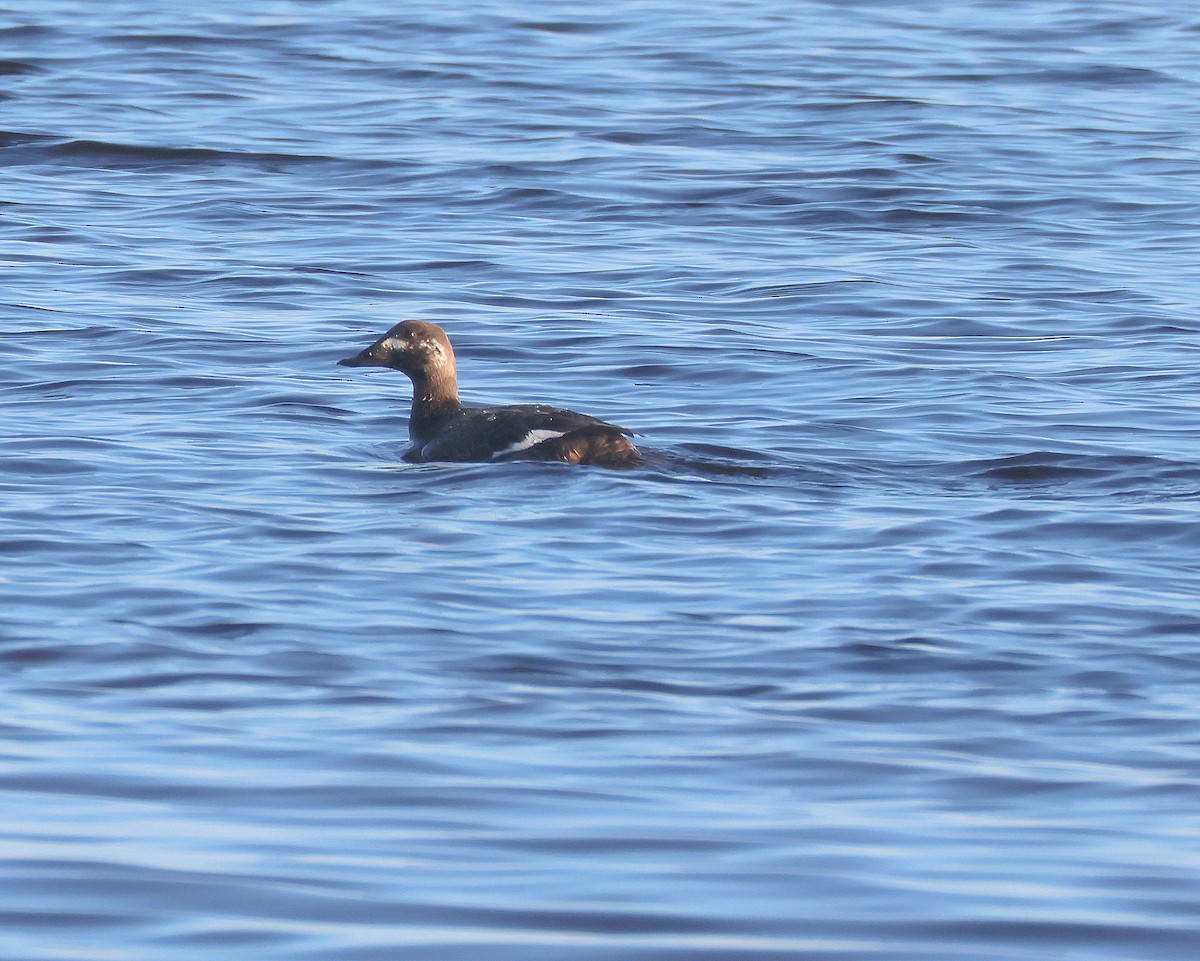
[338,320,641,467]
